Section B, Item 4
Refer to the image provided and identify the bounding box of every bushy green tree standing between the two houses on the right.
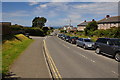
[84,21,98,35]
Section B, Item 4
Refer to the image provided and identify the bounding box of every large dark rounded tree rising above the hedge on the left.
[32,17,47,28]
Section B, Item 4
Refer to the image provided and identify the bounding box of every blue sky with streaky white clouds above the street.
[2,2,118,27]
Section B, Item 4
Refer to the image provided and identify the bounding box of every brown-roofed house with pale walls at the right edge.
[97,15,120,30]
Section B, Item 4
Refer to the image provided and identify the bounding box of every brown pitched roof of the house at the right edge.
[98,16,120,23]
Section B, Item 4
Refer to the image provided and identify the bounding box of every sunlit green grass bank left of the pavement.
[2,34,33,74]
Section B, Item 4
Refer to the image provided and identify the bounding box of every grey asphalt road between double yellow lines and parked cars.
[45,36,118,78]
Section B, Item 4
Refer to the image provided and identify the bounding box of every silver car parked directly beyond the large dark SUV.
[76,38,94,49]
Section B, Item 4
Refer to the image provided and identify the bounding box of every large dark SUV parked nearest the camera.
[95,38,120,61]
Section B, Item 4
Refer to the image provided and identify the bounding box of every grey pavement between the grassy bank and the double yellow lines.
[10,37,50,78]
